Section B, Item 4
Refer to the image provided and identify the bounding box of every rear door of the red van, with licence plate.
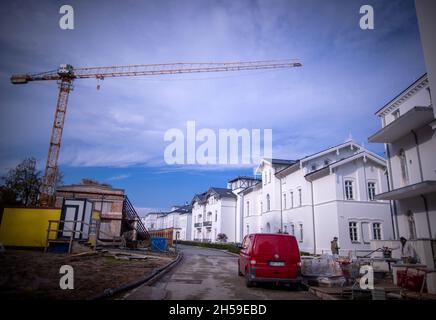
[252,234,300,279]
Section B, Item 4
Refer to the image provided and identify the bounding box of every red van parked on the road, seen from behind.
[238,233,302,287]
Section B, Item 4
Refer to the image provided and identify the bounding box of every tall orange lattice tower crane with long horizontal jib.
[11,59,302,206]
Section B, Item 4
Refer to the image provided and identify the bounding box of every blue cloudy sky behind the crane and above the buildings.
[0,0,425,214]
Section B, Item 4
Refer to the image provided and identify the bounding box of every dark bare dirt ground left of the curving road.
[0,250,172,299]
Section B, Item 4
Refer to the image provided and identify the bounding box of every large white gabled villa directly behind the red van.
[239,141,393,254]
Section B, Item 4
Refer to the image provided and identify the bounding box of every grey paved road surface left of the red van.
[125,246,318,300]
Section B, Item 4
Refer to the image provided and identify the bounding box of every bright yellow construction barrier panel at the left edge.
[0,208,61,248]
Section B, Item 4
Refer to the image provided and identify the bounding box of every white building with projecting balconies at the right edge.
[368,74,436,239]
